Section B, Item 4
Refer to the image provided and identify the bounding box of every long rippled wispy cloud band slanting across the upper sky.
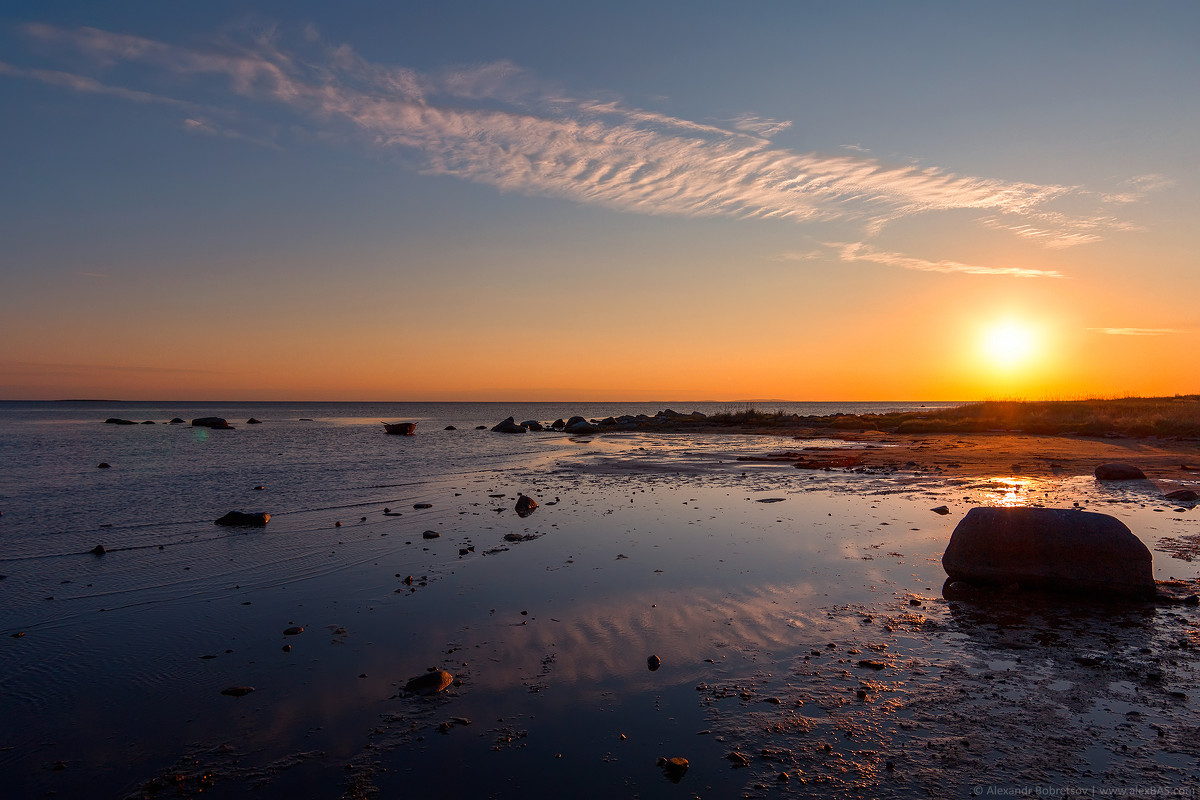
[4,24,1152,253]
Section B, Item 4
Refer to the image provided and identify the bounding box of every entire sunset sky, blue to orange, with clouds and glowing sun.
[0,0,1200,402]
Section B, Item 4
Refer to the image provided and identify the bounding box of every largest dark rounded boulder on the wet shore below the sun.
[942,507,1156,597]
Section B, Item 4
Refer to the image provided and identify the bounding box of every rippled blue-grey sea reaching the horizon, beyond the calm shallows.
[0,401,953,563]
